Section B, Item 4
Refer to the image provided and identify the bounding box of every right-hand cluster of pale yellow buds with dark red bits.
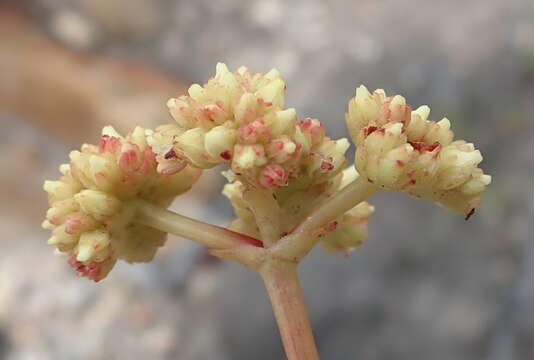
[346,86,491,214]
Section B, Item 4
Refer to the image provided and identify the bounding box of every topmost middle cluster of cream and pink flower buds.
[151,63,349,189]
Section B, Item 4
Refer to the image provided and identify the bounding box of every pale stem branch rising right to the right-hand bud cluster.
[272,177,380,261]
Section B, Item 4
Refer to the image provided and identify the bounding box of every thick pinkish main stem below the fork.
[260,260,319,360]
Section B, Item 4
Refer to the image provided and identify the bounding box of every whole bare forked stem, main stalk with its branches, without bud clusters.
[136,178,379,360]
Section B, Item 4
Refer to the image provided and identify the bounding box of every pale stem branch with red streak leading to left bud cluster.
[135,200,263,249]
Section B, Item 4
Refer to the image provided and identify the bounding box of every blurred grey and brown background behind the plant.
[0,0,534,360]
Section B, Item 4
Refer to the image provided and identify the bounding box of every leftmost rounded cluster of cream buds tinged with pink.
[43,127,201,281]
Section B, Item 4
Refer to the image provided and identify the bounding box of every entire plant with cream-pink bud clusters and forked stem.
[43,64,491,360]
